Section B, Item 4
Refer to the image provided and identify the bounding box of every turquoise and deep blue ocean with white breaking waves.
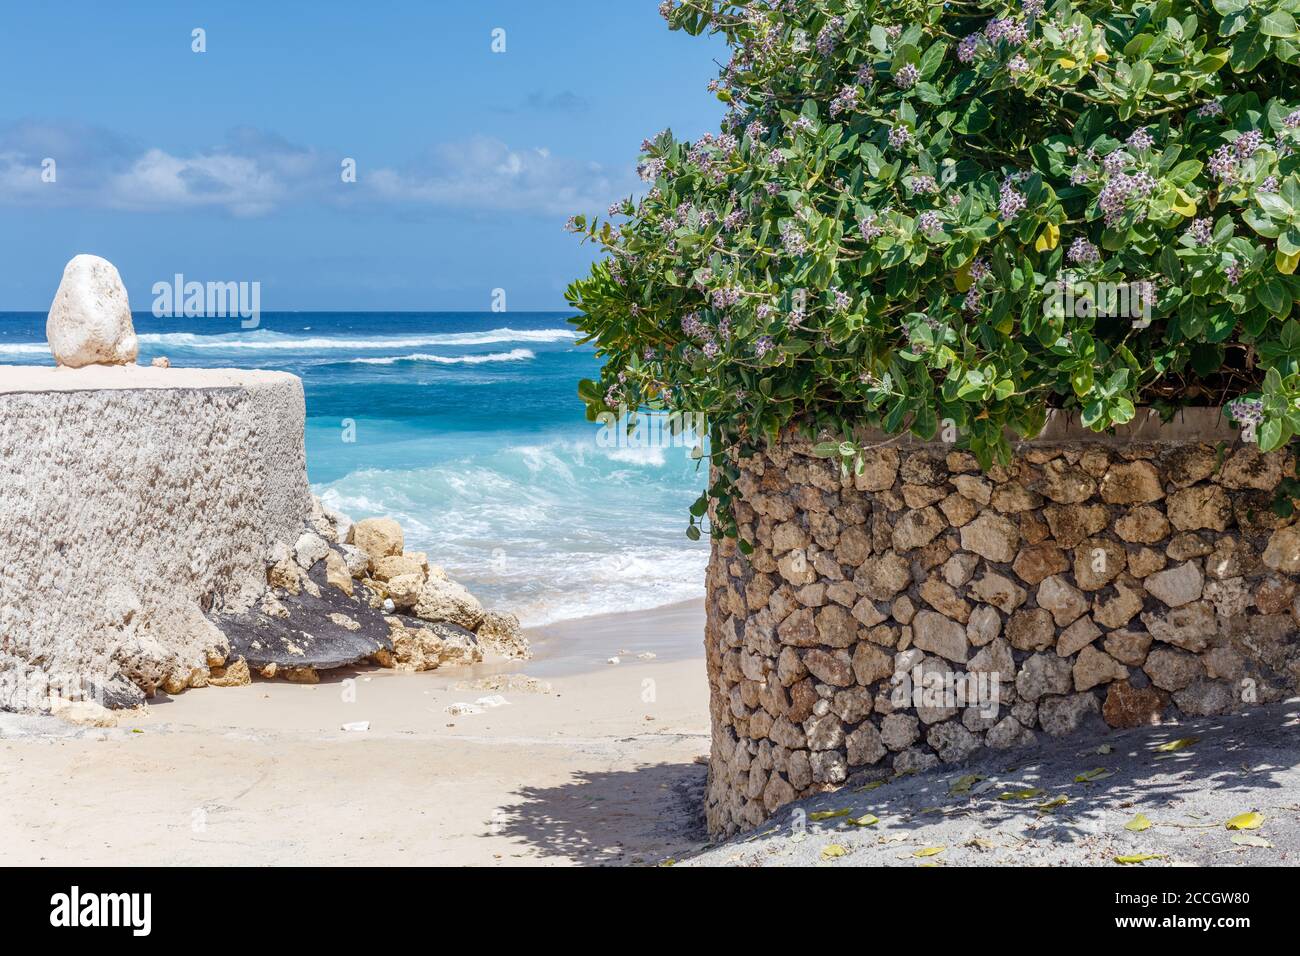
[0,312,707,626]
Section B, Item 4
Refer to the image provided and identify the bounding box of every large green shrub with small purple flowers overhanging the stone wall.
[568,0,1300,536]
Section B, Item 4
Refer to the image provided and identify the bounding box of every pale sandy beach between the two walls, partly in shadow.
[0,602,709,866]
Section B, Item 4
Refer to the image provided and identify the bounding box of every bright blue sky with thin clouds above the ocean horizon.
[0,0,725,311]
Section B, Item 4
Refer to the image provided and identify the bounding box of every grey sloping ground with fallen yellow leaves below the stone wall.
[677,698,1300,866]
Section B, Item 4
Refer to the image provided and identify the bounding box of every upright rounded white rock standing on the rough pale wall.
[46,255,139,368]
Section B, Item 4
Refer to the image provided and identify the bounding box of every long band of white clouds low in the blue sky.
[0,124,636,216]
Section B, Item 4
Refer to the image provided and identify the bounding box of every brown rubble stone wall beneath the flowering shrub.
[706,410,1300,834]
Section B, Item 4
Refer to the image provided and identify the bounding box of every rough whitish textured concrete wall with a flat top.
[0,367,311,709]
